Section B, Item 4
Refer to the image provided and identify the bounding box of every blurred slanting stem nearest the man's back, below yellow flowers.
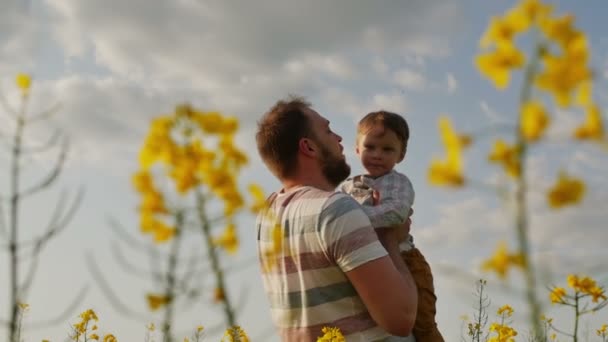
[196,192,236,327]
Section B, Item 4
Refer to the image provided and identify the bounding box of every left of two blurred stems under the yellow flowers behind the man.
[162,212,184,342]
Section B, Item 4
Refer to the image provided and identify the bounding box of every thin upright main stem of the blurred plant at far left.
[9,93,28,342]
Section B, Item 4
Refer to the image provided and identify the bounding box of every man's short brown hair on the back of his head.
[255,95,312,179]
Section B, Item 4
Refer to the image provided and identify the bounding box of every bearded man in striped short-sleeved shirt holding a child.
[256,98,417,342]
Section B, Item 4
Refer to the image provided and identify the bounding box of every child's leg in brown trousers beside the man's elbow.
[401,248,444,342]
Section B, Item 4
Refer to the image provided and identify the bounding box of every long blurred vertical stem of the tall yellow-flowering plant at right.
[515,44,542,336]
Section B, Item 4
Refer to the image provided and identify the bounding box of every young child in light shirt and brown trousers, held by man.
[338,111,443,342]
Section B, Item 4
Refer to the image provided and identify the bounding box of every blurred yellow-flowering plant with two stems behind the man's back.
[89,105,265,341]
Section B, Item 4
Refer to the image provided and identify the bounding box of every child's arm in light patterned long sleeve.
[363,173,414,228]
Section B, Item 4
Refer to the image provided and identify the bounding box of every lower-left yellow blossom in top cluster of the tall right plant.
[476,44,525,89]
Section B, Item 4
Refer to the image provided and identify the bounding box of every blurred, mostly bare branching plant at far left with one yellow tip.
[0,74,84,342]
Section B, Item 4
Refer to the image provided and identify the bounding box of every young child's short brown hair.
[357,110,410,153]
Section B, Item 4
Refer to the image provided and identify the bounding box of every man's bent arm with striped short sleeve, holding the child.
[319,194,418,336]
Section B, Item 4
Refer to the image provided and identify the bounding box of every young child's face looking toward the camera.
[356,127,403,177]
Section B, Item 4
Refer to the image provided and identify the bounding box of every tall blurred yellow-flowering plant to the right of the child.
[428,0,607,334]
